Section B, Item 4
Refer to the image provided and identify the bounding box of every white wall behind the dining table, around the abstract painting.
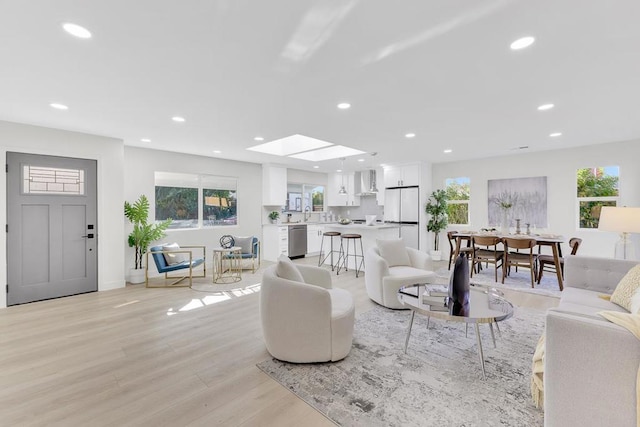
[433,141,640,257]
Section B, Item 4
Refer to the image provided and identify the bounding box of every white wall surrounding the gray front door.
[0,121,125,307]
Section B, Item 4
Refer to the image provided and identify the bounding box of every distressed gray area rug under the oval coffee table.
[258,307,544,427]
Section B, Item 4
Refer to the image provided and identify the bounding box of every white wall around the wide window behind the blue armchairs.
[120,147,262,272]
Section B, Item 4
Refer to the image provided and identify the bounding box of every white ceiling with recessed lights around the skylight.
[0,0,640,172]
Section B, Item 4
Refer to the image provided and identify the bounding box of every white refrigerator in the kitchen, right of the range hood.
[384,186,420,249]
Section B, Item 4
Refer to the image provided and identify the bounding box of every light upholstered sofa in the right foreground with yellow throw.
[544,256,640,427]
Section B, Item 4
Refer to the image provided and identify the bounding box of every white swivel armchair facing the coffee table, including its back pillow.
[364,239,436,308]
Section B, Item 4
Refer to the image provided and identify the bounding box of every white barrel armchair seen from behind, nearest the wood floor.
[260,260,355,363]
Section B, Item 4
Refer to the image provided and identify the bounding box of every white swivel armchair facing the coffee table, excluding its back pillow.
[364,247,436,309]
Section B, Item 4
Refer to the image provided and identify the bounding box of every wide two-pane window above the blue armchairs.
[155,172,238,229]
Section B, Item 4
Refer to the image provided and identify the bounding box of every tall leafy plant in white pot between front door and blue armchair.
[124,194,171,283]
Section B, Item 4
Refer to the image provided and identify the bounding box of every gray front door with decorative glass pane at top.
[7,152,98,305]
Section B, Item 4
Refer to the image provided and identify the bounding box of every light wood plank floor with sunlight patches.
[0,257,557,426]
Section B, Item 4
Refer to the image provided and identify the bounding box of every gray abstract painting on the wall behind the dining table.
[487,176,547,232]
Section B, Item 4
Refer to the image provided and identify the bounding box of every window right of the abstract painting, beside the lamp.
[576,166,620,228]
